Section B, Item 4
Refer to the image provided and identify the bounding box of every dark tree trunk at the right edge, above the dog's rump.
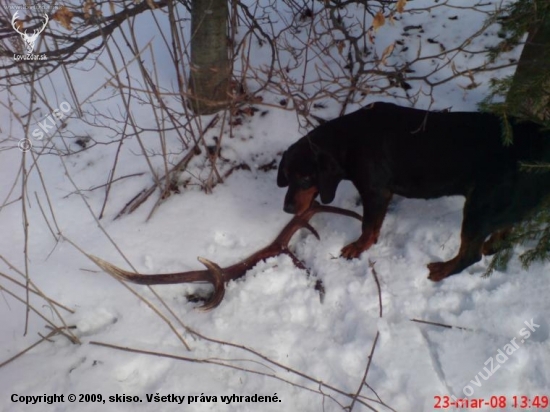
[506,6,550,122]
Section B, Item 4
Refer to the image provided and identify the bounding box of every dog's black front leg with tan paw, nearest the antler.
[341,190,392,259]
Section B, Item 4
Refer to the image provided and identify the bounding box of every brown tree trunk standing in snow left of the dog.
[189,0,230,114]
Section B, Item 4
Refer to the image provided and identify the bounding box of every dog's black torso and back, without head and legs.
[311,103,550,198]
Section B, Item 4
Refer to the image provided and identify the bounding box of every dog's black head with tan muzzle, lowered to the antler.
[277,136,344,215]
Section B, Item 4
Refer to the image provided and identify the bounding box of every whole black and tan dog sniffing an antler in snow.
[277,103,550,281]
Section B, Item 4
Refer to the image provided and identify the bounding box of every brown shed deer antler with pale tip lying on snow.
[91,202,361,310]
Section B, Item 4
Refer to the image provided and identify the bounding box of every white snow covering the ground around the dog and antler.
[0,0,550,412]
